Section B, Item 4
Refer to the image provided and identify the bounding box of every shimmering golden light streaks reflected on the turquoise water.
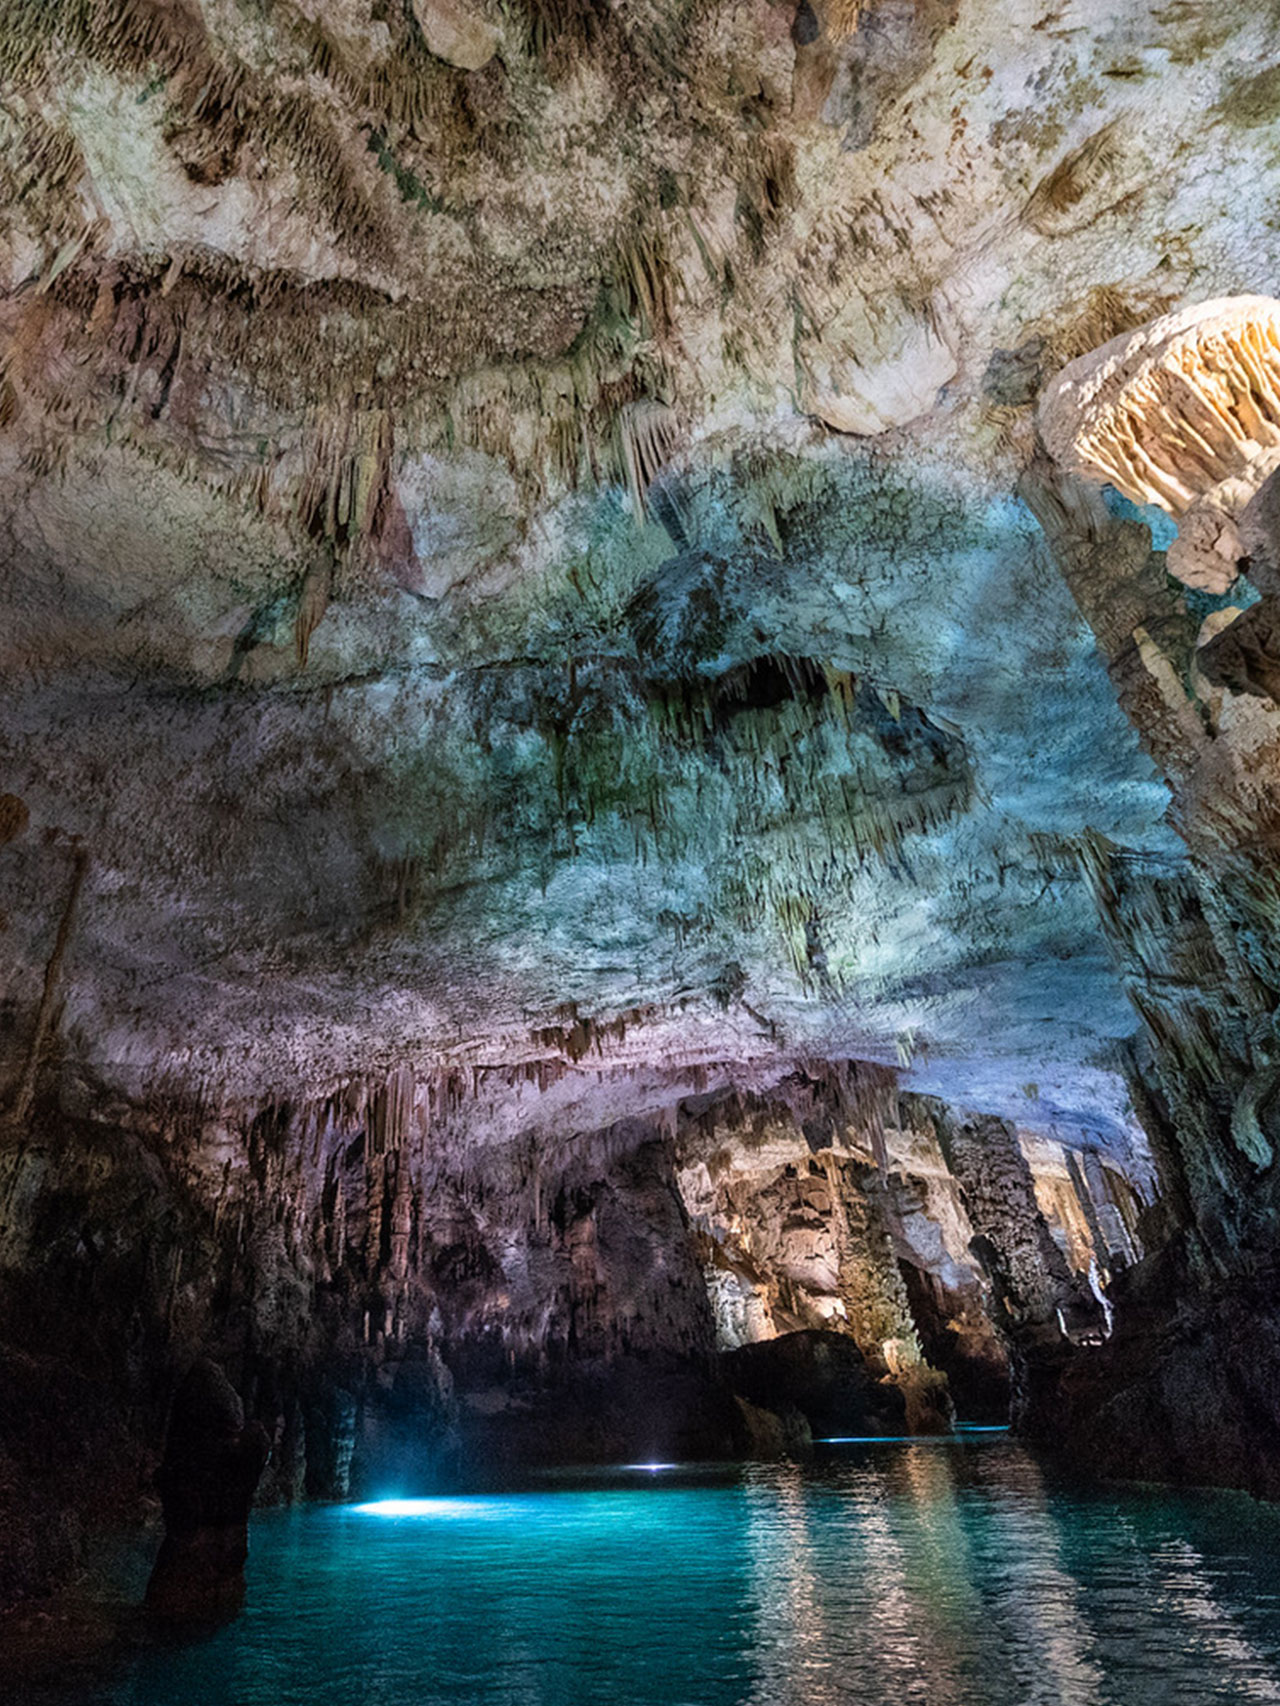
[748,1445,1104,1706]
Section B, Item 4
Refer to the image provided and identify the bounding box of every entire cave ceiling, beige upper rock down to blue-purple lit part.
[0,0,1280,1134]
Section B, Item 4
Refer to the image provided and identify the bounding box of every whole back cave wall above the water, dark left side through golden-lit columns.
[0,1063,1140,1595]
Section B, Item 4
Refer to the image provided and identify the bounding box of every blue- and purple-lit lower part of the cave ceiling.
[3,445,1172,1143]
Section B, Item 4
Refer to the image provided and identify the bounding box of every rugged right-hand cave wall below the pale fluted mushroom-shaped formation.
[1024,450,1280,1496]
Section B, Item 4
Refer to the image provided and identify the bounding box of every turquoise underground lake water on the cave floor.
[67,1438,1280,1706]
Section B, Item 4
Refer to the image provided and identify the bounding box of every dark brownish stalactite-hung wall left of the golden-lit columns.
[0,1076,730,1595]
